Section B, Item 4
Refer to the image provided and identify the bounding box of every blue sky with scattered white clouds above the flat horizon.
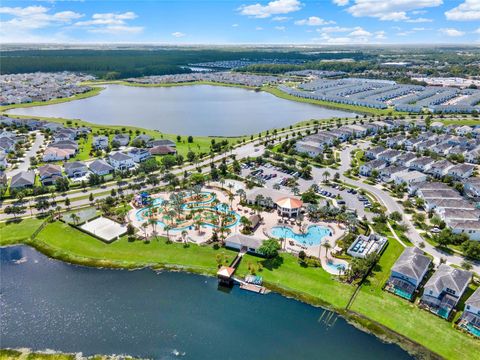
[0,0,480,45]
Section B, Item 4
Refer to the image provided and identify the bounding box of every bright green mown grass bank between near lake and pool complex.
[0,220,480,359]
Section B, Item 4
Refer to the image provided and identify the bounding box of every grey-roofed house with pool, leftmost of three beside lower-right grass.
[385,247,432,300]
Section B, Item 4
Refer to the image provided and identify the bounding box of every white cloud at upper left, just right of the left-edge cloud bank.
[74,11,143,35]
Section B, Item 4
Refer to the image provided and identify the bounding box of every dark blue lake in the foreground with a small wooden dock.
[0,246,411,360]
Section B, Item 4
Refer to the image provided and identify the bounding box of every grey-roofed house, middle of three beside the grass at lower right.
[421,264,472,319]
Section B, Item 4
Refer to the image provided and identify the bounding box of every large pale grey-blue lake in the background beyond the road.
[5,85,356,136]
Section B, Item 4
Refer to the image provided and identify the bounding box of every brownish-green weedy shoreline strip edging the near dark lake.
[7,241,442,360]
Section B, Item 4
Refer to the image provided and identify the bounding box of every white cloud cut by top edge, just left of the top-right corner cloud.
[347,0,443,21]
